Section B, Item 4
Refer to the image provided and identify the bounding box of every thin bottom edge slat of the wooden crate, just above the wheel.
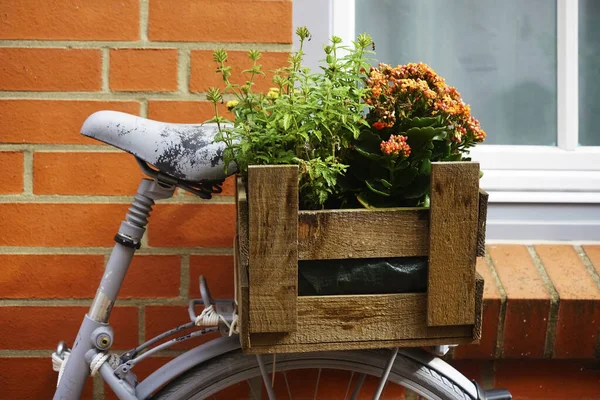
[243,334,475,354]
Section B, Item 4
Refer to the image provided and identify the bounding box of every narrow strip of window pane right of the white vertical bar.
[579,0,600,146]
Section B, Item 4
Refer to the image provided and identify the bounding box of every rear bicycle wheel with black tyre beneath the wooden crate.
[153,350,472,400]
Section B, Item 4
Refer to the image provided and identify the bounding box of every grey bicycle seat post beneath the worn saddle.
[88,178,175,323]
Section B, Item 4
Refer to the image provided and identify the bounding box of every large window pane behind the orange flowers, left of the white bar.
[355,0,556,145]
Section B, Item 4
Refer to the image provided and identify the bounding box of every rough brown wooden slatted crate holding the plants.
[234,162,487,353]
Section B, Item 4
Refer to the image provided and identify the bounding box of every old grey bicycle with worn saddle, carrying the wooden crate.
[52,111,512,400]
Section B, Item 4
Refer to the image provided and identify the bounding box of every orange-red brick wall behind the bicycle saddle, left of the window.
[0,0,292,400]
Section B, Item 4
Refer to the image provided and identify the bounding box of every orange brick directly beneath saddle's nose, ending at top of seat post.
[33,152,145,196]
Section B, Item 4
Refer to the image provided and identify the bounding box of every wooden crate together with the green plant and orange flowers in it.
[207,28,485,353]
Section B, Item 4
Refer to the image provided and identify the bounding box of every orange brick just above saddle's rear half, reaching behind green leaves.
[148,100,233,124]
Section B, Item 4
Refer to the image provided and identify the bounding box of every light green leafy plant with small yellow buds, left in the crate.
[207,27,372,209]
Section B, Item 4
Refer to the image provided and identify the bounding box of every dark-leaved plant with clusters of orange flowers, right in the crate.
[342,63,485,207]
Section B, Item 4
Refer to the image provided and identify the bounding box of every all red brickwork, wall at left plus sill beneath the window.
[0,0,600,399]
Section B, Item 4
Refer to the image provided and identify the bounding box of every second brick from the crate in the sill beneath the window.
[488,245,550,359]
